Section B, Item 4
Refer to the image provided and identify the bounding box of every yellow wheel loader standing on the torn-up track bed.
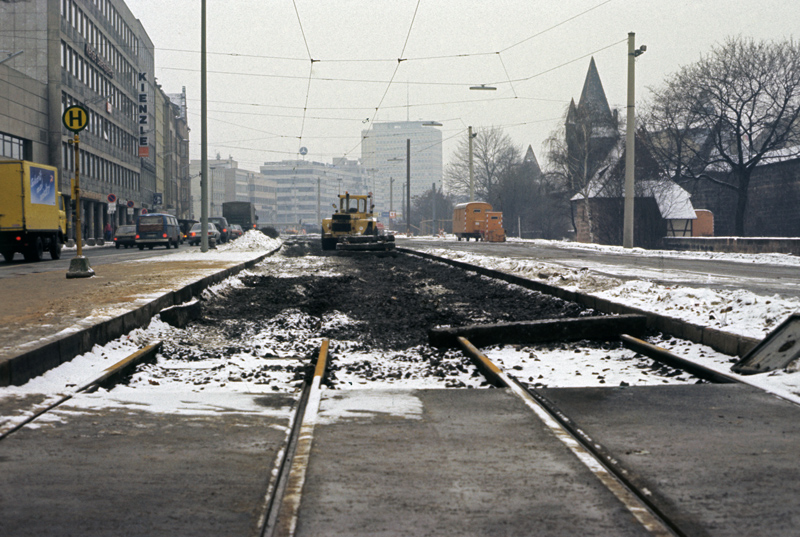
[322,192,394,252]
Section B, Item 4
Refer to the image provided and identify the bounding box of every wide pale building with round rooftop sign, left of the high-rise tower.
[261,158,370,227]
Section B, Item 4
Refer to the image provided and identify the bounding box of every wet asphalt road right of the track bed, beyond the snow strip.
[398,239,800,297]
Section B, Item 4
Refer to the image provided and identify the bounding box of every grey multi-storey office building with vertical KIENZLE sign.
[0,0,188,237]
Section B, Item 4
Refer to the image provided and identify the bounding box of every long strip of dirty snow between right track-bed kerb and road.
[423,245,800,339]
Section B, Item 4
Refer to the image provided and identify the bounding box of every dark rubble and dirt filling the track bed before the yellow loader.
[201,241,591,350]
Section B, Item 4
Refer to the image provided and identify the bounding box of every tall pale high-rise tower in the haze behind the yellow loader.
[361,121,442,221]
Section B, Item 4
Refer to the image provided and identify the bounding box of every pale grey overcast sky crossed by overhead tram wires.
[127,0,800,170]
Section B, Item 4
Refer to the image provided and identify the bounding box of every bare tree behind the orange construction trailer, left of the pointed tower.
[444,127,520,207]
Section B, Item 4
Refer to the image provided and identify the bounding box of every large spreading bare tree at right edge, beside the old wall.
[646,37,800,235]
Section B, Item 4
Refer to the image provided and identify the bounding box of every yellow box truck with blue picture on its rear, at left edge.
[0,160,67,262]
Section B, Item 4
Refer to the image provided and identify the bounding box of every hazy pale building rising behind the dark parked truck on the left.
[190,155,277,224]
